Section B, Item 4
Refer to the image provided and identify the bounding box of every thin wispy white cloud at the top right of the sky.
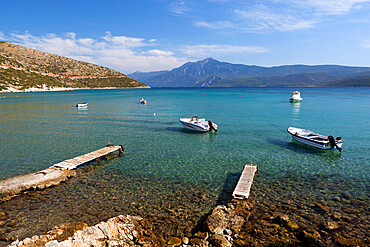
[194,0,370,32]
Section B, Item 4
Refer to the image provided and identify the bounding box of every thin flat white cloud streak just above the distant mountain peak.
[181,45,269,57]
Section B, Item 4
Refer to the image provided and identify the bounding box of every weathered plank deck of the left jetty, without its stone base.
[52,146,122,170]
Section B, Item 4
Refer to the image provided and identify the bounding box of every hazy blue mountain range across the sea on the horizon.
[129,58,370,87]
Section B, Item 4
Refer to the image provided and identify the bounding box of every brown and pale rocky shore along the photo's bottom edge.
[4,199,369,247]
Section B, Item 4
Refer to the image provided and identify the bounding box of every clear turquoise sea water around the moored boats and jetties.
[0,88,370,241]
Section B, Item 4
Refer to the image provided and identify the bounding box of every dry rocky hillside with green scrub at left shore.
[0,41,146,91]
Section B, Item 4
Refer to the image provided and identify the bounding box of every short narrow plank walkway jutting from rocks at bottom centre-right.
[233,164,258,199]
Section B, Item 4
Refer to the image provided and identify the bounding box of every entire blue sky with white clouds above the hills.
[0,0,370,74]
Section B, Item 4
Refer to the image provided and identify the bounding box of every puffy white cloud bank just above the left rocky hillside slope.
[5,32,186,74]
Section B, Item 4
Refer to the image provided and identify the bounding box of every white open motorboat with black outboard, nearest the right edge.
[287,127,343,152]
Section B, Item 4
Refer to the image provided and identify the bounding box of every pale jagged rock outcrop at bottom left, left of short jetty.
[10,215,165,247]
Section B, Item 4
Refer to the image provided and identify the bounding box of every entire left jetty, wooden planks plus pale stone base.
[0,145,124,201]
